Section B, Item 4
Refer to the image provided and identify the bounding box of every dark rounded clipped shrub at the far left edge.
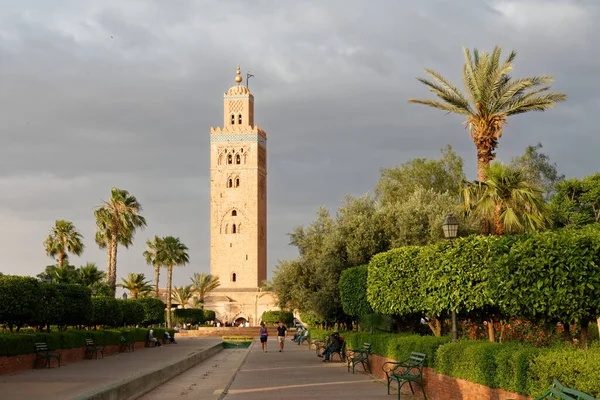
[0,275,41,331]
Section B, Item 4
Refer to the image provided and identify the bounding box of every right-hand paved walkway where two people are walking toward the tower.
[220,340,420,400]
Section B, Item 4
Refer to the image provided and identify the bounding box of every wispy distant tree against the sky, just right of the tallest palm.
[511,142,565,199]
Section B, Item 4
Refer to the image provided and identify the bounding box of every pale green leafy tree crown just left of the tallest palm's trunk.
[375,145,465,206]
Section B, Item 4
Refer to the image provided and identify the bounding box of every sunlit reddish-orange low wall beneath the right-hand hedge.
[366,355,531,400]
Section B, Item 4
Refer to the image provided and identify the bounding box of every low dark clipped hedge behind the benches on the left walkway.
[0,328,175,357]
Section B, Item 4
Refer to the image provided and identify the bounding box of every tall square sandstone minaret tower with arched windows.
[210,65,267,291]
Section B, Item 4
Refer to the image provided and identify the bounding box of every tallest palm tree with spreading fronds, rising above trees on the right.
[408,46,567,182]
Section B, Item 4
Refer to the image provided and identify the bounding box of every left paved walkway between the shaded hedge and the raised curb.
[0,338,221,400]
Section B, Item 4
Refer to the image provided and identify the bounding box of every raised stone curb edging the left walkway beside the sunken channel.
[73,343,223,400]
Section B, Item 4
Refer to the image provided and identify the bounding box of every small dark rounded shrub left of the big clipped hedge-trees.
[339,265,373,317]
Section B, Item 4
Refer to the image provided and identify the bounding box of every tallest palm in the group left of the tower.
[94,188,146,292]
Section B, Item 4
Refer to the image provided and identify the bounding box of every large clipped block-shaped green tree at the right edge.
[489,226,600,345]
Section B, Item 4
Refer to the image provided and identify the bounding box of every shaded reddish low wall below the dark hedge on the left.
[0,342,145,375]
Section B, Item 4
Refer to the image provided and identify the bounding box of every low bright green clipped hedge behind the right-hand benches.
[310,329,600,397]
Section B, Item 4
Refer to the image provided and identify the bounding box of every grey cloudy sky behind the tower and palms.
[0,0,600,290]
